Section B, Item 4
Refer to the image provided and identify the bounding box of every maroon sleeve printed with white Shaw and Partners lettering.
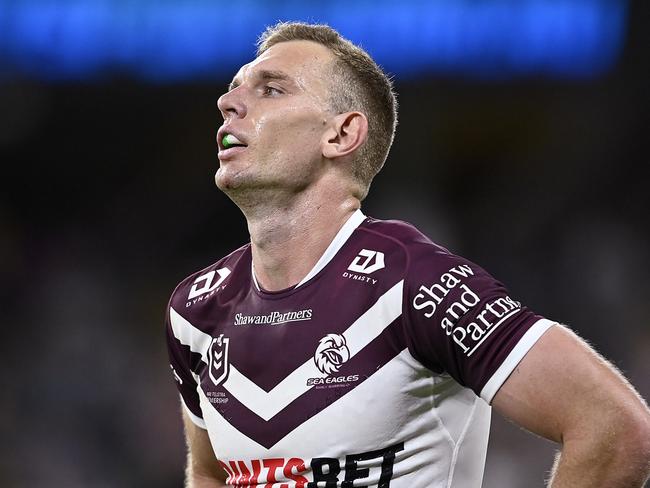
[404,245,542,401]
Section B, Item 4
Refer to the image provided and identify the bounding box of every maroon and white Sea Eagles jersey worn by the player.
[167,211,552,488]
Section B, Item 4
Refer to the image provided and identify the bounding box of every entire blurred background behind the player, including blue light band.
[0,0,650,488]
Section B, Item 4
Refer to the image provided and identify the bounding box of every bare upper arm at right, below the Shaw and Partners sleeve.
[492,325,648,443]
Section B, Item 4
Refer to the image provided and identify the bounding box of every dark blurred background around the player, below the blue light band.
[0,1,650,488]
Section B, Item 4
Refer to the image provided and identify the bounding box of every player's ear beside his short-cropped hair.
[321,112,368,159]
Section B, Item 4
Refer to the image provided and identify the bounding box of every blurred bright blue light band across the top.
[0,0,627,82]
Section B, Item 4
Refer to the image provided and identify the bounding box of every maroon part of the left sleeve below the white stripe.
[165,307,203,423]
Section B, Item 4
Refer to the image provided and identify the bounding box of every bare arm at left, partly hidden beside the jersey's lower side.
[183,409,226,488]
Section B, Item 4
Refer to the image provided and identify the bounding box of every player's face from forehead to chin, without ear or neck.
[216,41,335,192]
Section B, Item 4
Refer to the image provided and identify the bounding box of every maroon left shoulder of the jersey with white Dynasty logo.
[169,243,250,309]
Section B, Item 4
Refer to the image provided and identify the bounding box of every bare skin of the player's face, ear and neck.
[216,41,367,290]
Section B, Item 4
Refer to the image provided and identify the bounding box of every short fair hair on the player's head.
[257,22,397,199]
